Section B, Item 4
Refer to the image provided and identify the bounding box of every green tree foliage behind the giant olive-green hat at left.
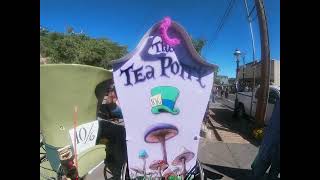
[40,27,127,69]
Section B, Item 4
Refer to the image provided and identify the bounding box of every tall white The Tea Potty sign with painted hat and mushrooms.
[113,17,216,178]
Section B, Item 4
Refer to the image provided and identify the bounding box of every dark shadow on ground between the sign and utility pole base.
[209,109,259,147]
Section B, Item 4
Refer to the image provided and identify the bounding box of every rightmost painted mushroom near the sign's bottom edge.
[172,148,194,179]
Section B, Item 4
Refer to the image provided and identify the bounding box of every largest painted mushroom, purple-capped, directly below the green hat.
[144,123,179,164]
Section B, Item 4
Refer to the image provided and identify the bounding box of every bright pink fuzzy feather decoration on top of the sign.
[160,17,180,46]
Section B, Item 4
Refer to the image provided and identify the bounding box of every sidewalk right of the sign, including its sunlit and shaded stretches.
[198,101,258,179]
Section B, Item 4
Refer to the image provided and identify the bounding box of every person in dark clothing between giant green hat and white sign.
[97,82,127,179]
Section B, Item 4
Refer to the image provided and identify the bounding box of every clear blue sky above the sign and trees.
[40,0,280,77]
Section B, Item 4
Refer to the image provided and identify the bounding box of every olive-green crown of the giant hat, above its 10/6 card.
[40,64,112,147]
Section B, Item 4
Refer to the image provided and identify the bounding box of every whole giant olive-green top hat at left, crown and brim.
[40,64,112,180]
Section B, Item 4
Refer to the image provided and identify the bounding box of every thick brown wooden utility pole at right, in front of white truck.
[255,0,270,127]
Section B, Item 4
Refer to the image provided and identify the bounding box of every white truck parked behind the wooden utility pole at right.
[237,85,280,124]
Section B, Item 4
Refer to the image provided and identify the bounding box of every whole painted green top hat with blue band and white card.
[151,86,180,115]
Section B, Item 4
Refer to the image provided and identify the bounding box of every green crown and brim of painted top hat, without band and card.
[151,86,180,114]
